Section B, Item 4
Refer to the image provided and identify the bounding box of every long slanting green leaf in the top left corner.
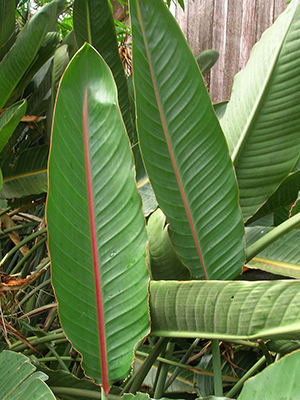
[0,2,56,110]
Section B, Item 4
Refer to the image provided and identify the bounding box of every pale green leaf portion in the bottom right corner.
[238,350,300,400]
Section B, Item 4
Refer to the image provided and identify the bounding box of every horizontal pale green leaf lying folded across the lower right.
[150,281,300,340]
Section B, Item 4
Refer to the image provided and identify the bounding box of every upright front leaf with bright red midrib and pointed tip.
[47,44,149,394]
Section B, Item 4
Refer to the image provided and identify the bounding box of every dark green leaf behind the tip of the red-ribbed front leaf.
[73,0,136,142]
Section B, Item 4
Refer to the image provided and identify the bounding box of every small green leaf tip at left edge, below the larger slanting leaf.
[0,100,27,153]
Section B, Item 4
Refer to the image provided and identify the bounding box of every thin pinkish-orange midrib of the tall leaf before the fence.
[137,2,207,280]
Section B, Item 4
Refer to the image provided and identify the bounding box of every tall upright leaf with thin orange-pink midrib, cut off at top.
[130,0,244,279]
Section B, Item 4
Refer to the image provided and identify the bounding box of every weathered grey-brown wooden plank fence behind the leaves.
[176,0,287,103]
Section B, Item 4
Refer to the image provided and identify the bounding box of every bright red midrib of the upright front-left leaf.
[83,88,109,396]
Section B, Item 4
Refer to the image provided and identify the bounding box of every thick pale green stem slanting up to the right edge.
[246,213,300,263]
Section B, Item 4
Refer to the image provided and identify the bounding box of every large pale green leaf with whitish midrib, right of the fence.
[221,0,300,220]
